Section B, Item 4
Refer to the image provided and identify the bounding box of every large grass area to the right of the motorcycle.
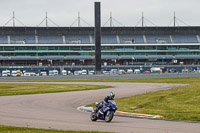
[116,78,200,121]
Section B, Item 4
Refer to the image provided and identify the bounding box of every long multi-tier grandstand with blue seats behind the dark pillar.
[0,27,200,66]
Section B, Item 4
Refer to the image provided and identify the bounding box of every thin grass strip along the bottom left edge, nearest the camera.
[0,125,111,133]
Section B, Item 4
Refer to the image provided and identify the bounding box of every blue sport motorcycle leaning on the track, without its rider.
[90,100,117,122]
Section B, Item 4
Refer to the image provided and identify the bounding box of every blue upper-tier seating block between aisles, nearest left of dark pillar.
[65,35,90,44]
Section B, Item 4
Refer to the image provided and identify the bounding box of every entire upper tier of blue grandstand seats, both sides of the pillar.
[0,34,198,44]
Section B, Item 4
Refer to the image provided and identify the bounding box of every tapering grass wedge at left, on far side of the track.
[0,83,111,96]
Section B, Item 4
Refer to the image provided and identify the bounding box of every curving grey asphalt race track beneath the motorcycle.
[0,82,200,133]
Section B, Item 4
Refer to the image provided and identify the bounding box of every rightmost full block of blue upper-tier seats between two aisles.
[172,35,198,43]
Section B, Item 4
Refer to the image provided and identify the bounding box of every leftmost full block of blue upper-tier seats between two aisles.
[10,35,35,44]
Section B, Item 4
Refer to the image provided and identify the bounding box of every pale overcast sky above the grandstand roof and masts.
[0,0,200,26]
